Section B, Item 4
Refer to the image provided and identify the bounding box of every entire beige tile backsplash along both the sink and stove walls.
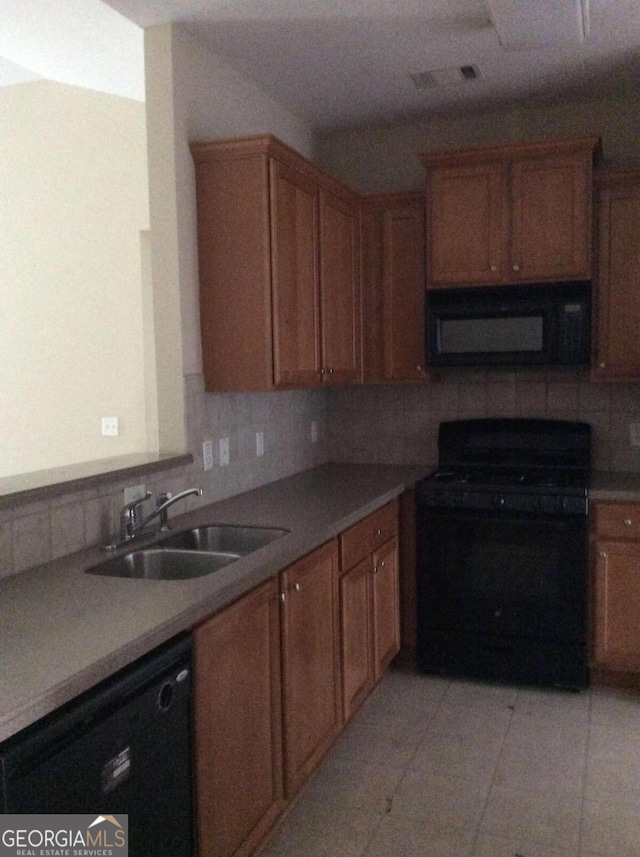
[0,372,640,576]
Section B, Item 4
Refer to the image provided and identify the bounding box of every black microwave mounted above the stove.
[426,281,591,368]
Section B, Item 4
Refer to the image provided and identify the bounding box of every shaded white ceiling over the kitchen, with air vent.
[100,0,640,127]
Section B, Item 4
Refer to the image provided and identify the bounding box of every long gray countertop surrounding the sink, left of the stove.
[0,465,427,740]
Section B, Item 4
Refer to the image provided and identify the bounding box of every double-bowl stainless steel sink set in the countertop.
[87,547,240,580]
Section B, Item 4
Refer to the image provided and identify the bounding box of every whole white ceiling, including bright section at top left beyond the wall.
[5,0,640,128]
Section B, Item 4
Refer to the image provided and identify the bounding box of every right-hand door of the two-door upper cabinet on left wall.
[320,190,361,384]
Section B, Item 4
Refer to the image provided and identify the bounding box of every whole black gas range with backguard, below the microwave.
[416,419,591,687]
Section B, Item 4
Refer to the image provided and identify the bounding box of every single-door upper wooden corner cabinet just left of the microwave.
[361,192,427,383]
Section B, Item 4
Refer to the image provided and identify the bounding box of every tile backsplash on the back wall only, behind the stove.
[328,372,640,473]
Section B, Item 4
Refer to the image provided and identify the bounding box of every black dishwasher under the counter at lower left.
[0,635,194,857]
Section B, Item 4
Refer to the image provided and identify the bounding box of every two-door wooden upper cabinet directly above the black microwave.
[420,137,599,288]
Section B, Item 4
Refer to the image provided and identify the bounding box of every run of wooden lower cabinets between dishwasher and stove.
[193,512,399,857]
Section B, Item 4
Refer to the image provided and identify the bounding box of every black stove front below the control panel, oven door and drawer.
[417,508,587,685]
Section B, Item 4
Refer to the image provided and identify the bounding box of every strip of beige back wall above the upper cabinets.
[317,97,640,193]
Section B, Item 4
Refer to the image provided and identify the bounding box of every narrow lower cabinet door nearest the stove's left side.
[372,539,400,681]
